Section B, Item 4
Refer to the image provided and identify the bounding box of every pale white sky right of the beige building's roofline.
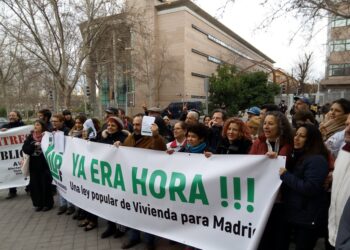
[195,0,327,79]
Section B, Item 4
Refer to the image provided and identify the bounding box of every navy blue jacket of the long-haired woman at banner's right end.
[281,155,328,227]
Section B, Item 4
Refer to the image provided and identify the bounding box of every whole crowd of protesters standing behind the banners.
[2,97,350,250]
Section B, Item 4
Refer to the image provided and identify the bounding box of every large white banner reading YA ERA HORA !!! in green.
[42,134,285,250]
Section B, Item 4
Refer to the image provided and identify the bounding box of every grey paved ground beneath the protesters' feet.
[0,188,324,250]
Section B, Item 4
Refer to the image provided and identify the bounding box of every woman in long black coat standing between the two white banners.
[22,120,54,212]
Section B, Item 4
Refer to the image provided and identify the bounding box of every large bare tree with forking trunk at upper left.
[0,0,125,110]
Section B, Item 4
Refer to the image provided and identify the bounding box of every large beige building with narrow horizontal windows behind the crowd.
[83,0,274,113]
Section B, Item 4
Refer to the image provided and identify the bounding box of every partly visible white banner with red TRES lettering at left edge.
[0,125,33,189]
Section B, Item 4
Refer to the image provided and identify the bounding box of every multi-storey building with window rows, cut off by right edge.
[321,9,350,99]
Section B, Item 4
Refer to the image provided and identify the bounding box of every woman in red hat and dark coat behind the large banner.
[98,116,129,239]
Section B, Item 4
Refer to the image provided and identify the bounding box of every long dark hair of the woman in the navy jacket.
[298,123,329,161]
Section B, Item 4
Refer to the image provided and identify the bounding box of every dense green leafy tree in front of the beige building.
[209,65,280,115]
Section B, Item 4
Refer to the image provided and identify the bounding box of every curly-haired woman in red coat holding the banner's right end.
[249,111,293,250]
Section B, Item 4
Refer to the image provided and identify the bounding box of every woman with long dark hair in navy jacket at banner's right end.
[279,124,329,250]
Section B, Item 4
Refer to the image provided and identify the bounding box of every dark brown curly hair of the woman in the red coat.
[260,111,293,145]
